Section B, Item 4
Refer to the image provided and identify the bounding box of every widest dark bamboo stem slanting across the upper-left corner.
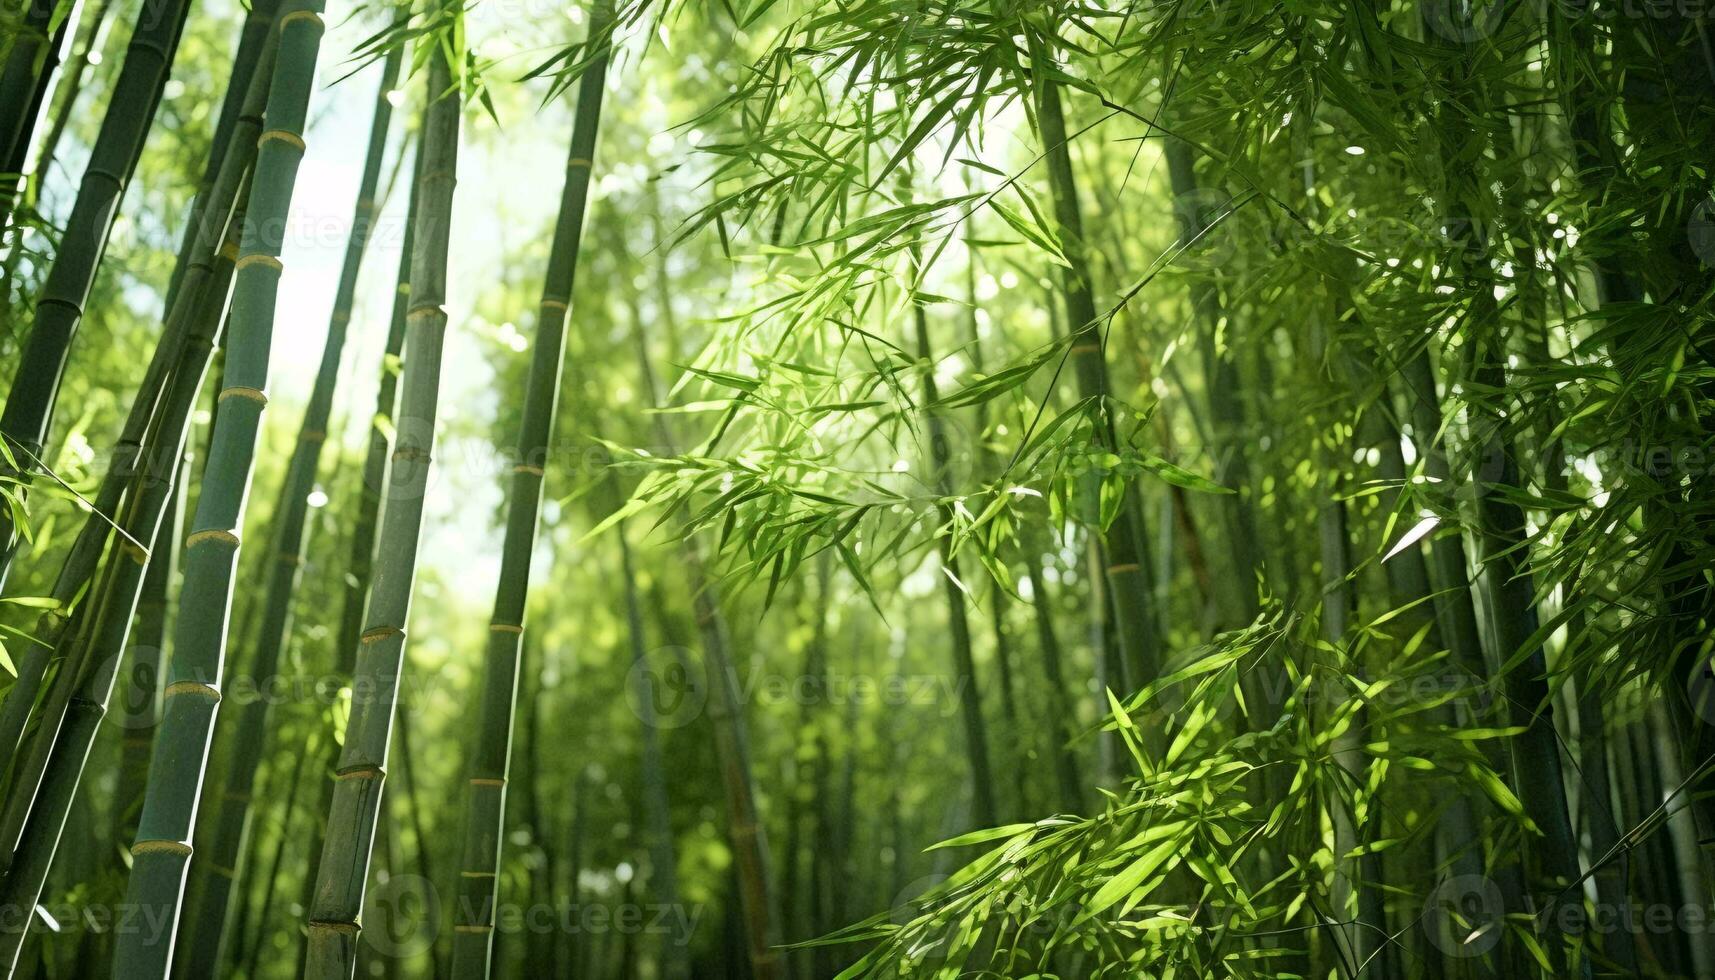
[0,0,190,585]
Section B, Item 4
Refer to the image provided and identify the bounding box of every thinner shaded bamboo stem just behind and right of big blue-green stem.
[189,48,405,963]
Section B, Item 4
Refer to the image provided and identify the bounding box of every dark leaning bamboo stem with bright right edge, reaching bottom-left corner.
[0,187,237,977]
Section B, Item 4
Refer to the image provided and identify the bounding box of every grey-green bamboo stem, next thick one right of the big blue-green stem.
[305,28,460,980]
